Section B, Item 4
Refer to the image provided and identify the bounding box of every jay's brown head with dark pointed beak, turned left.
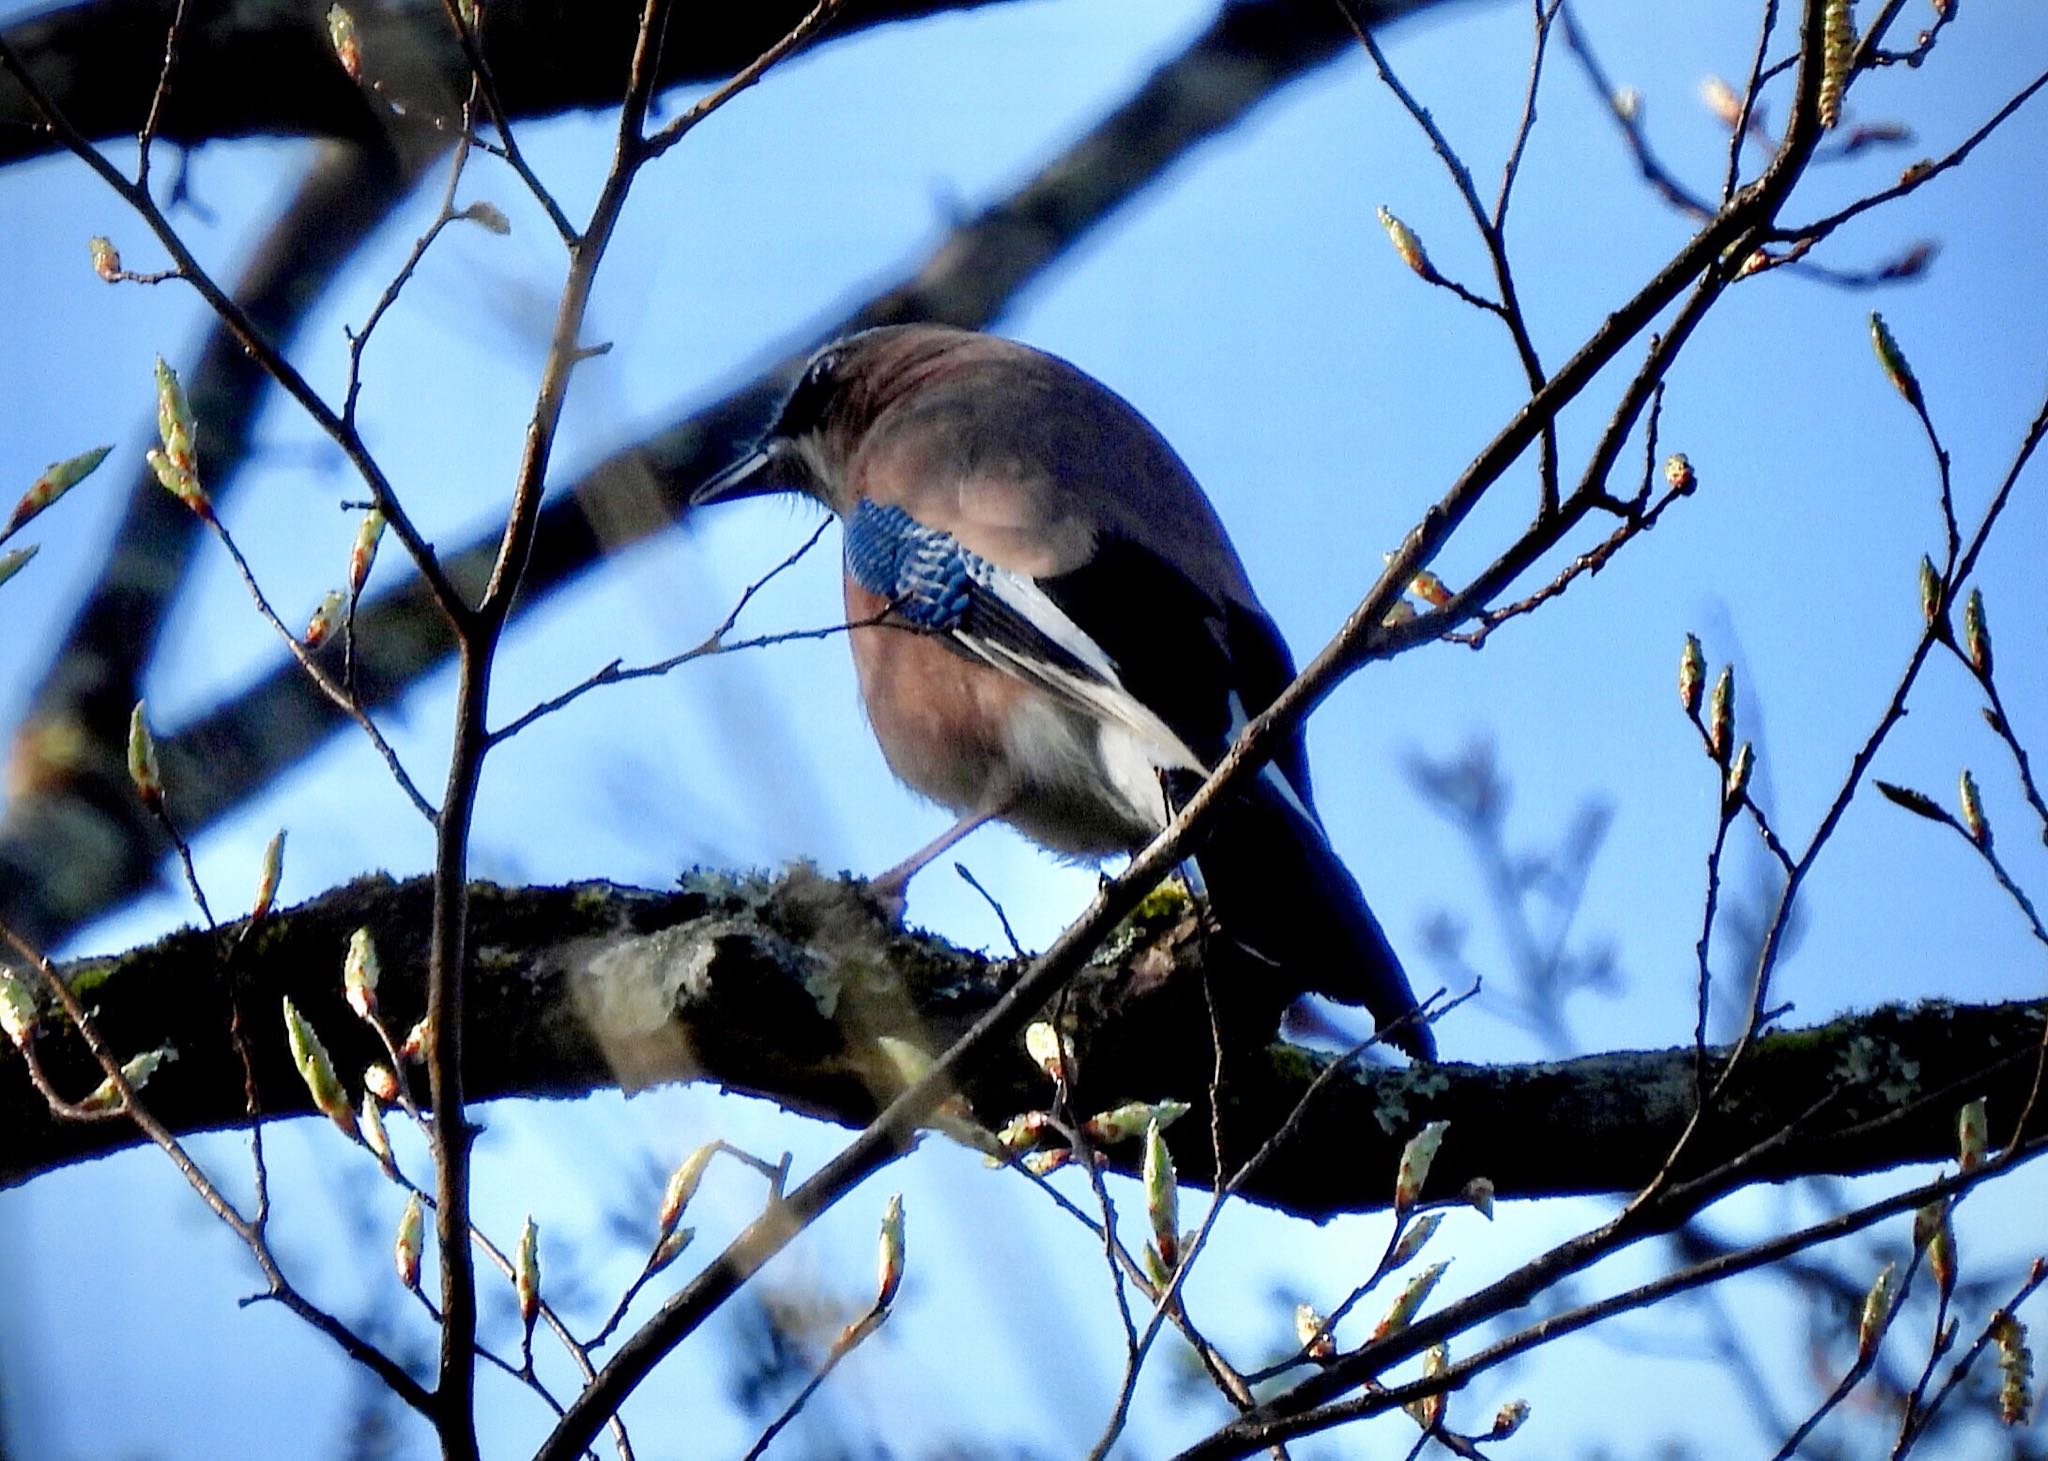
[690,324,970,514]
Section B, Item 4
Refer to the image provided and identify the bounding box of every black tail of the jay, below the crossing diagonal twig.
[1176,766,1436,1059]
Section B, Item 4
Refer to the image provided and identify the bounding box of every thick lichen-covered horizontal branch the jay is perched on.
[0,869,2048,1219]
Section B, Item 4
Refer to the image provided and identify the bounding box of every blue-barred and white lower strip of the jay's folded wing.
[846,500,1206,770]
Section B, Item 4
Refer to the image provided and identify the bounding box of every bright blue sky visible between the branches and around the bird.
[0,0,2048,1457]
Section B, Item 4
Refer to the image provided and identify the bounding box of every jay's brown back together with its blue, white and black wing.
[848,338,1313,805]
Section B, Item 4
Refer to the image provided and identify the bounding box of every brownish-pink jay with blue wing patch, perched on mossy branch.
[690,324,1436,1059]
